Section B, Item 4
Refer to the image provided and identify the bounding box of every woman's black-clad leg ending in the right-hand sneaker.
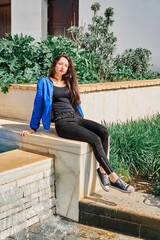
[56,120,134,192]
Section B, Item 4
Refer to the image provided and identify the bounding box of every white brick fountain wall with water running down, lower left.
[0,153,56,240]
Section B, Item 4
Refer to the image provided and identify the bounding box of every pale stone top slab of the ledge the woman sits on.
[0,117,91,156]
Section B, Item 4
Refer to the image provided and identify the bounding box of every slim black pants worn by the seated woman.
[55,113,113,174]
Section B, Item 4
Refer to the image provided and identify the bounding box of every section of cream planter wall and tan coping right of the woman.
[80,79,160,123]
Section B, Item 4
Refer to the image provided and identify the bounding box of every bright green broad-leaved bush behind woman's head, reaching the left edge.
[0,34,99,93]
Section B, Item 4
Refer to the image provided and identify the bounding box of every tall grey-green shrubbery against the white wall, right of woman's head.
[68,2,160,81]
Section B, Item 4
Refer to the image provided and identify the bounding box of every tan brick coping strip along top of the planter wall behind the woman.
[10,79,160,93]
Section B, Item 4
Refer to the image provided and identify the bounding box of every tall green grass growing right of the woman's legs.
[103,114,160,195]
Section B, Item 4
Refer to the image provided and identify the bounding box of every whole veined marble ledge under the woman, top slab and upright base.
[0,118,100,221]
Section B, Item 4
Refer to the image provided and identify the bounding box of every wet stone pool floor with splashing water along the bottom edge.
[6,216,142,240]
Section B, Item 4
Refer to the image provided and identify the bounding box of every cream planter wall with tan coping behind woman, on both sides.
[0,79,160,123]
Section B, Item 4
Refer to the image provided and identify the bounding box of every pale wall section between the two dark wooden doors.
[11,0,48,41]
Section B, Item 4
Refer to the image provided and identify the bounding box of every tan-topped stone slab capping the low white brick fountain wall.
[0,149,54,185]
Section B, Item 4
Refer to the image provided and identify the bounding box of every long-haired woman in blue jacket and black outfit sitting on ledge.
[21,55,134,193]
